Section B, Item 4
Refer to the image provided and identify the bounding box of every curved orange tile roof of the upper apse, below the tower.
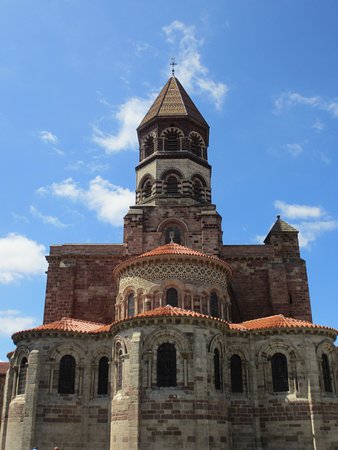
[114,242,233,276]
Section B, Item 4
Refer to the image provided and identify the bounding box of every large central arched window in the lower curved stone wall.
[157,342,176,387]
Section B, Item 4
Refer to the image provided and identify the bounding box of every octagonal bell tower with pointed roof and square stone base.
[124,75,222,254]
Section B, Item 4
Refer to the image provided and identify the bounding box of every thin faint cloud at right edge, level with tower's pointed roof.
[274,92,338,118]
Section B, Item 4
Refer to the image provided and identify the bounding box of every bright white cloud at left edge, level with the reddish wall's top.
[0,233,47,283]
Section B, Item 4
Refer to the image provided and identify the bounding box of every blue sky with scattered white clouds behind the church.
[0,0,338,360]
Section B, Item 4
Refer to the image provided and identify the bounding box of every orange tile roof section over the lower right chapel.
[239,314,337,331]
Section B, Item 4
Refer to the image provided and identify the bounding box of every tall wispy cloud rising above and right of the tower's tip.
[163,20,229,109]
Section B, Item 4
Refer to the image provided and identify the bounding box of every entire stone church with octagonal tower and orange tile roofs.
[0,75,338,450]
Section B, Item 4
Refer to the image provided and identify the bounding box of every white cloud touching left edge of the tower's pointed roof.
[92,95,154,154]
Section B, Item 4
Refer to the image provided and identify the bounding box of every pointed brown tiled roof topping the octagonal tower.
[138,76,209,128]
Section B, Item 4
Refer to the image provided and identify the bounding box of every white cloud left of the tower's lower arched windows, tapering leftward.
[39,176,135,226]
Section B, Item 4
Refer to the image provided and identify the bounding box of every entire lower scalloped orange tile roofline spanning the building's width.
[12,305,338,342]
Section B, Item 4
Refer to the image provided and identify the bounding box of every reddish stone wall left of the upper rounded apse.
[44,245,127,323]
